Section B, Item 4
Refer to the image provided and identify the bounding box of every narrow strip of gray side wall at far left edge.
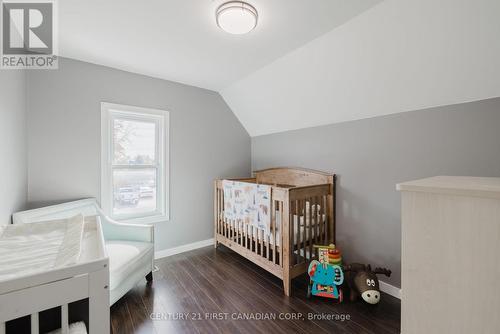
[0,70,27,224]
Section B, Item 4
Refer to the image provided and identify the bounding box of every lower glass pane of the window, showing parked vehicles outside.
[113,168,156,215]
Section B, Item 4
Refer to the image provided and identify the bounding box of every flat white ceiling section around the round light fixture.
[58,0,381,91]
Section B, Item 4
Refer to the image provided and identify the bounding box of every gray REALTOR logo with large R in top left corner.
[1,0,57,69]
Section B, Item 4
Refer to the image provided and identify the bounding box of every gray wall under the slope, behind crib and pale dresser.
[252,98,500,286]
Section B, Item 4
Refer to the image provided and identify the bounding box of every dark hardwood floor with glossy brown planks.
[111,246,400,334]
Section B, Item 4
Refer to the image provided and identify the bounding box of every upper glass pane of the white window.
[113,118,156,165]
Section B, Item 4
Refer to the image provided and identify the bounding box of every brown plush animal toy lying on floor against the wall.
[344,263,391,304]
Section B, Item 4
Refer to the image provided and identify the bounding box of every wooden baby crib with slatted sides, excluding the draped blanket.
[214,167,335,296]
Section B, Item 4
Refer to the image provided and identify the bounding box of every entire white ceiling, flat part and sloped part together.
[59,0,500,136]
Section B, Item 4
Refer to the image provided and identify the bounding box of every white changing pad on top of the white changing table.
[0,215,84,282]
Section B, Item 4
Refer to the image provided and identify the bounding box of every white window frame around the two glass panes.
[101,102,170,224]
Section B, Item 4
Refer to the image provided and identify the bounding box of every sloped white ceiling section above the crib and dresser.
[221,0,500,136]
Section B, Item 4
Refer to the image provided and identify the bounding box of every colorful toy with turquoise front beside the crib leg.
[307,245,344,302]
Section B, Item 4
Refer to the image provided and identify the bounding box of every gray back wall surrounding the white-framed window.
[28,59,250,250]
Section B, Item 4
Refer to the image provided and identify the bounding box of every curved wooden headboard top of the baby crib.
[254,167,335,187]
